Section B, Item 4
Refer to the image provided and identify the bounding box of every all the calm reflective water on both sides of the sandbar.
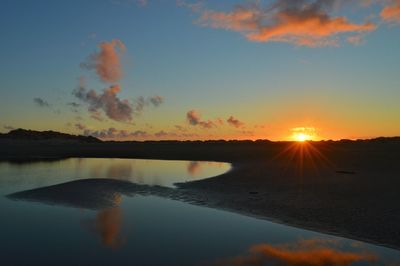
[0,159,400,265]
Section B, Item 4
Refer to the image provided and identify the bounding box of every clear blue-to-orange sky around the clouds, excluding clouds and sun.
[0,0,400,139]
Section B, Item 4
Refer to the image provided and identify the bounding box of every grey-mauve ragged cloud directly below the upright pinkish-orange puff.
[73,84,133,122]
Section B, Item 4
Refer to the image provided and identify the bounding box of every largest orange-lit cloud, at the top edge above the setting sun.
[192,0,376,47]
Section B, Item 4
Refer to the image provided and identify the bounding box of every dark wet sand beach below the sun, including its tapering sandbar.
[0,140,400,249]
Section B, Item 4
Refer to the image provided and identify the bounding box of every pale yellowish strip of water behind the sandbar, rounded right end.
[0,158,230,194]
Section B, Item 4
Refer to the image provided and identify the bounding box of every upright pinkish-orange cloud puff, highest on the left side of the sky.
[81,39,126,83]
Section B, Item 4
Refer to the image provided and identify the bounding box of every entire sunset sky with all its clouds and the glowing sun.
[0,0,400,140]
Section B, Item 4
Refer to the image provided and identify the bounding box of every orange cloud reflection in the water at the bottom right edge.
[211,238,378,266]
